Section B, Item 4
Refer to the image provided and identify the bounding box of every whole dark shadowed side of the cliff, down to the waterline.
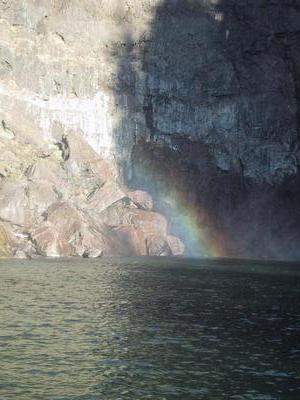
[115,0,300,258]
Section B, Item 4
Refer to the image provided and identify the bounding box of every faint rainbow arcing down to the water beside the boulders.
[133,142,232,258]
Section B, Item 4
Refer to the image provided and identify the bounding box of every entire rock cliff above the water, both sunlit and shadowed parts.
[0,0,300,258]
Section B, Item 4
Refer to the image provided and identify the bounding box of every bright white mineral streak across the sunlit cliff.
[0,85,117,158]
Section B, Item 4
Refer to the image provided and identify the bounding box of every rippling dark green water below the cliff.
[0,259,300,400]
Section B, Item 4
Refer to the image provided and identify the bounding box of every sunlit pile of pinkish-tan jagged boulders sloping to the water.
[0,112,184,258]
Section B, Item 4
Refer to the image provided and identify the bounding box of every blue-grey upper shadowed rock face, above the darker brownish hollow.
[116,0,300,182]
